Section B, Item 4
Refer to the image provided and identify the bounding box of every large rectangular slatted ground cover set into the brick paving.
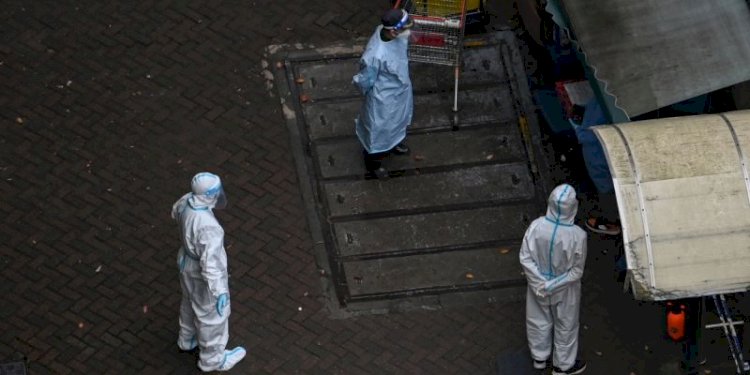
[269,32,547,311]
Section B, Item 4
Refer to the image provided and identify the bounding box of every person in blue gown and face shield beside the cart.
[352,9,414,178]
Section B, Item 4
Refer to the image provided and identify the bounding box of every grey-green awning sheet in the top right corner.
[557,0,750,117]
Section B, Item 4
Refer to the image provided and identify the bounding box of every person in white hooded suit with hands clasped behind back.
[519,184,587,375]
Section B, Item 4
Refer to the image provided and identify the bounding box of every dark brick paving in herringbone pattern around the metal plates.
[0,0,748,374]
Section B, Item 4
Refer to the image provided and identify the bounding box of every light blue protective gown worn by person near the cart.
[352,25,414,154]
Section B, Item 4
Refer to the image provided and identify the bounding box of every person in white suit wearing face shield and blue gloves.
[172,172,246,371]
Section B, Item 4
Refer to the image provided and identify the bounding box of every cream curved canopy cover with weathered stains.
[594,111,750,300]
